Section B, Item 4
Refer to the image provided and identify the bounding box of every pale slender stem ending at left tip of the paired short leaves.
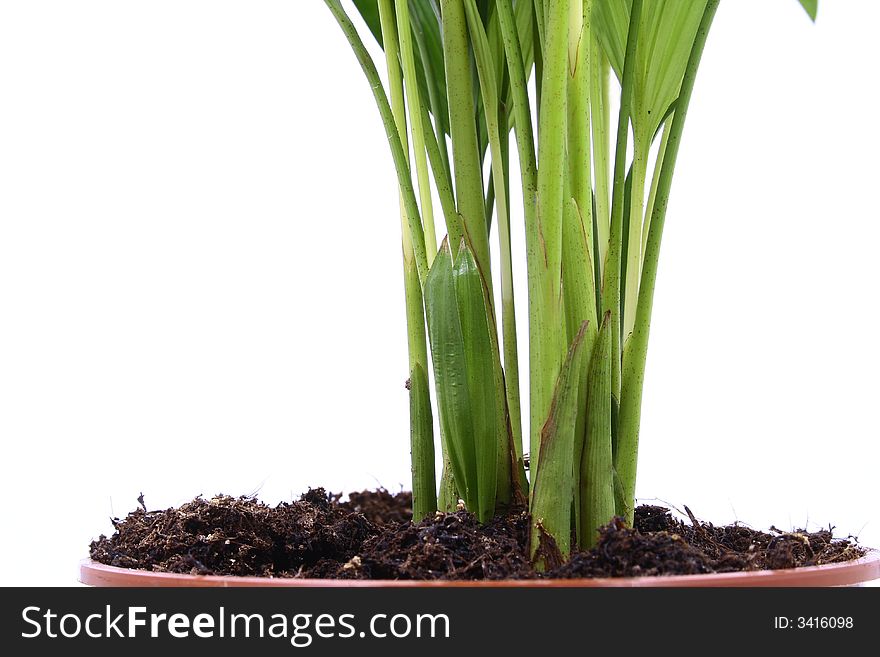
[396,0,437,267]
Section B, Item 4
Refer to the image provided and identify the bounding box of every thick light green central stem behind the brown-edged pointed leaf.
[526,0,569,474]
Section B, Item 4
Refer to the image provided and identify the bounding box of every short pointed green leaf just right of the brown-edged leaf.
[578,314,615,549]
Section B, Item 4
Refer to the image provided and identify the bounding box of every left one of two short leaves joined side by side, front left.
[425,240,478,509]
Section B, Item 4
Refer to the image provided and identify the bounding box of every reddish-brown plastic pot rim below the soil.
[79,550,880,588]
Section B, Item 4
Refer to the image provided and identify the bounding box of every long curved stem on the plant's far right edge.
[614,0,718,524]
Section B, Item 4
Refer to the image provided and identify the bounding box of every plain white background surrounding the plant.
[0,0,880,585]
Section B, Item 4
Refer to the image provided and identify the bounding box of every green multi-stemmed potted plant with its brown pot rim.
[83,0,880,586]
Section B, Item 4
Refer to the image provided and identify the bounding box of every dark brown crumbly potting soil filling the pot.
[90,488,864,580]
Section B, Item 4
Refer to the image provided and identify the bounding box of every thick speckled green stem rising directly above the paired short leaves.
[440,0,493,292]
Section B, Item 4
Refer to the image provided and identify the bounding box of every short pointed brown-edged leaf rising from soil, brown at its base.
[530,322,587,568]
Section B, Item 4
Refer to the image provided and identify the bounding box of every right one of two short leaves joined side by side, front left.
[452,240,504,522]
